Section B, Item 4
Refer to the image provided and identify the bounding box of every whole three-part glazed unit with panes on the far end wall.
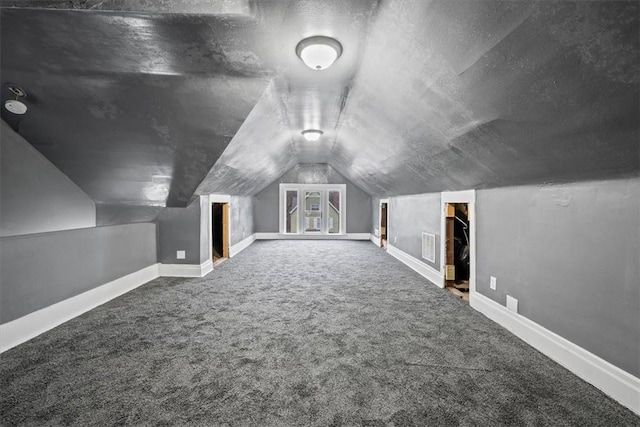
[280,184,346,235]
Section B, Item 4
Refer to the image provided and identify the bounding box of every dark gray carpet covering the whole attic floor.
[0,241,640,426]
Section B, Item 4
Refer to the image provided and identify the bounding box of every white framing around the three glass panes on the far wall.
[279,184,347,236]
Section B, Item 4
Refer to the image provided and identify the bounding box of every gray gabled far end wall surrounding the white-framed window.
[253,164,371,233]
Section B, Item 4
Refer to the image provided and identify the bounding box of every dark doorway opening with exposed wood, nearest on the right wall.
[444,203,471,301]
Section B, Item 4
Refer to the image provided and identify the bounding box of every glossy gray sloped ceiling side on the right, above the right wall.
[334,1,640,195]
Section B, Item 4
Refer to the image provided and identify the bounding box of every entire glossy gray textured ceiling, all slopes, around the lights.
[0,0,640,206]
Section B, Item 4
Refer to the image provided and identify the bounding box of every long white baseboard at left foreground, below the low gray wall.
[0,264,158,353]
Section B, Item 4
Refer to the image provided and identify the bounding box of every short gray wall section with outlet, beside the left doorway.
[158,197,202,265]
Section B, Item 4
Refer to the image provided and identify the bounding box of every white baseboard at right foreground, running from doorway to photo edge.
[469,292,640,415]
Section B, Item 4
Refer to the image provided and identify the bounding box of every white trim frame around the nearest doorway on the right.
[440,190,477,302]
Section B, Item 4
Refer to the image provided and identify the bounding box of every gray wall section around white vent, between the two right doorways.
[389,193,441,270]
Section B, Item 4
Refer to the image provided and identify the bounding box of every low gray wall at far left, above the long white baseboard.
[0,223,156,323]
